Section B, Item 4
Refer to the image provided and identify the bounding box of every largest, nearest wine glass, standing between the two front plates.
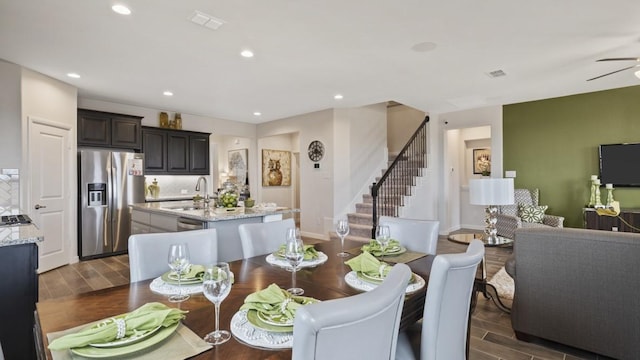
[202,262,232,345]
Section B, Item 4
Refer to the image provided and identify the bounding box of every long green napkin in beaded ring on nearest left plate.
[49,302,187,350]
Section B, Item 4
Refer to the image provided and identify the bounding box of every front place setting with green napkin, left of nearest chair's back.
[231,284,319,350]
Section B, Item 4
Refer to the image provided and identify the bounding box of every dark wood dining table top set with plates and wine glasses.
[36,240,434,359]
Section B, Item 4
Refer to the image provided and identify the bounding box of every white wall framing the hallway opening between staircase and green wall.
[432,106,503,233]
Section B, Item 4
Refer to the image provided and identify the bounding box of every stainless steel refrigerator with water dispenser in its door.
[78,149,144,259]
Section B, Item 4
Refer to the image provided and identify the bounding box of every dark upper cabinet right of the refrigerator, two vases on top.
[142,126,210,175]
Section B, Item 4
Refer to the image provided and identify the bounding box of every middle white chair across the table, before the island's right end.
[238,218,296,259]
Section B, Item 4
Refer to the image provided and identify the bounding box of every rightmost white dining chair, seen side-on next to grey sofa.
[396,239,484,360]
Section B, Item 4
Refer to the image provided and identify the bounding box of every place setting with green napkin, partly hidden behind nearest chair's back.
[344,251,426,294]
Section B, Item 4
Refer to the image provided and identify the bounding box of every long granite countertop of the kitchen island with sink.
[130,200,300,221]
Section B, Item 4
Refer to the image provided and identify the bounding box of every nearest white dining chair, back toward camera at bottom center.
[292,264,411,360]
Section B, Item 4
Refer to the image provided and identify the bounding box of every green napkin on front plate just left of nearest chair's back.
[240,284,317,320]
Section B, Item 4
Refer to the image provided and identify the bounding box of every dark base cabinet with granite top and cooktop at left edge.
[0,215,44,359]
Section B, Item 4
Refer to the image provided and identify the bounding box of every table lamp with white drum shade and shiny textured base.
[469,178,514,244]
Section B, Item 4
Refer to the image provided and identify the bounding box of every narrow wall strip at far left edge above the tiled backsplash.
[0,60,22,169]
